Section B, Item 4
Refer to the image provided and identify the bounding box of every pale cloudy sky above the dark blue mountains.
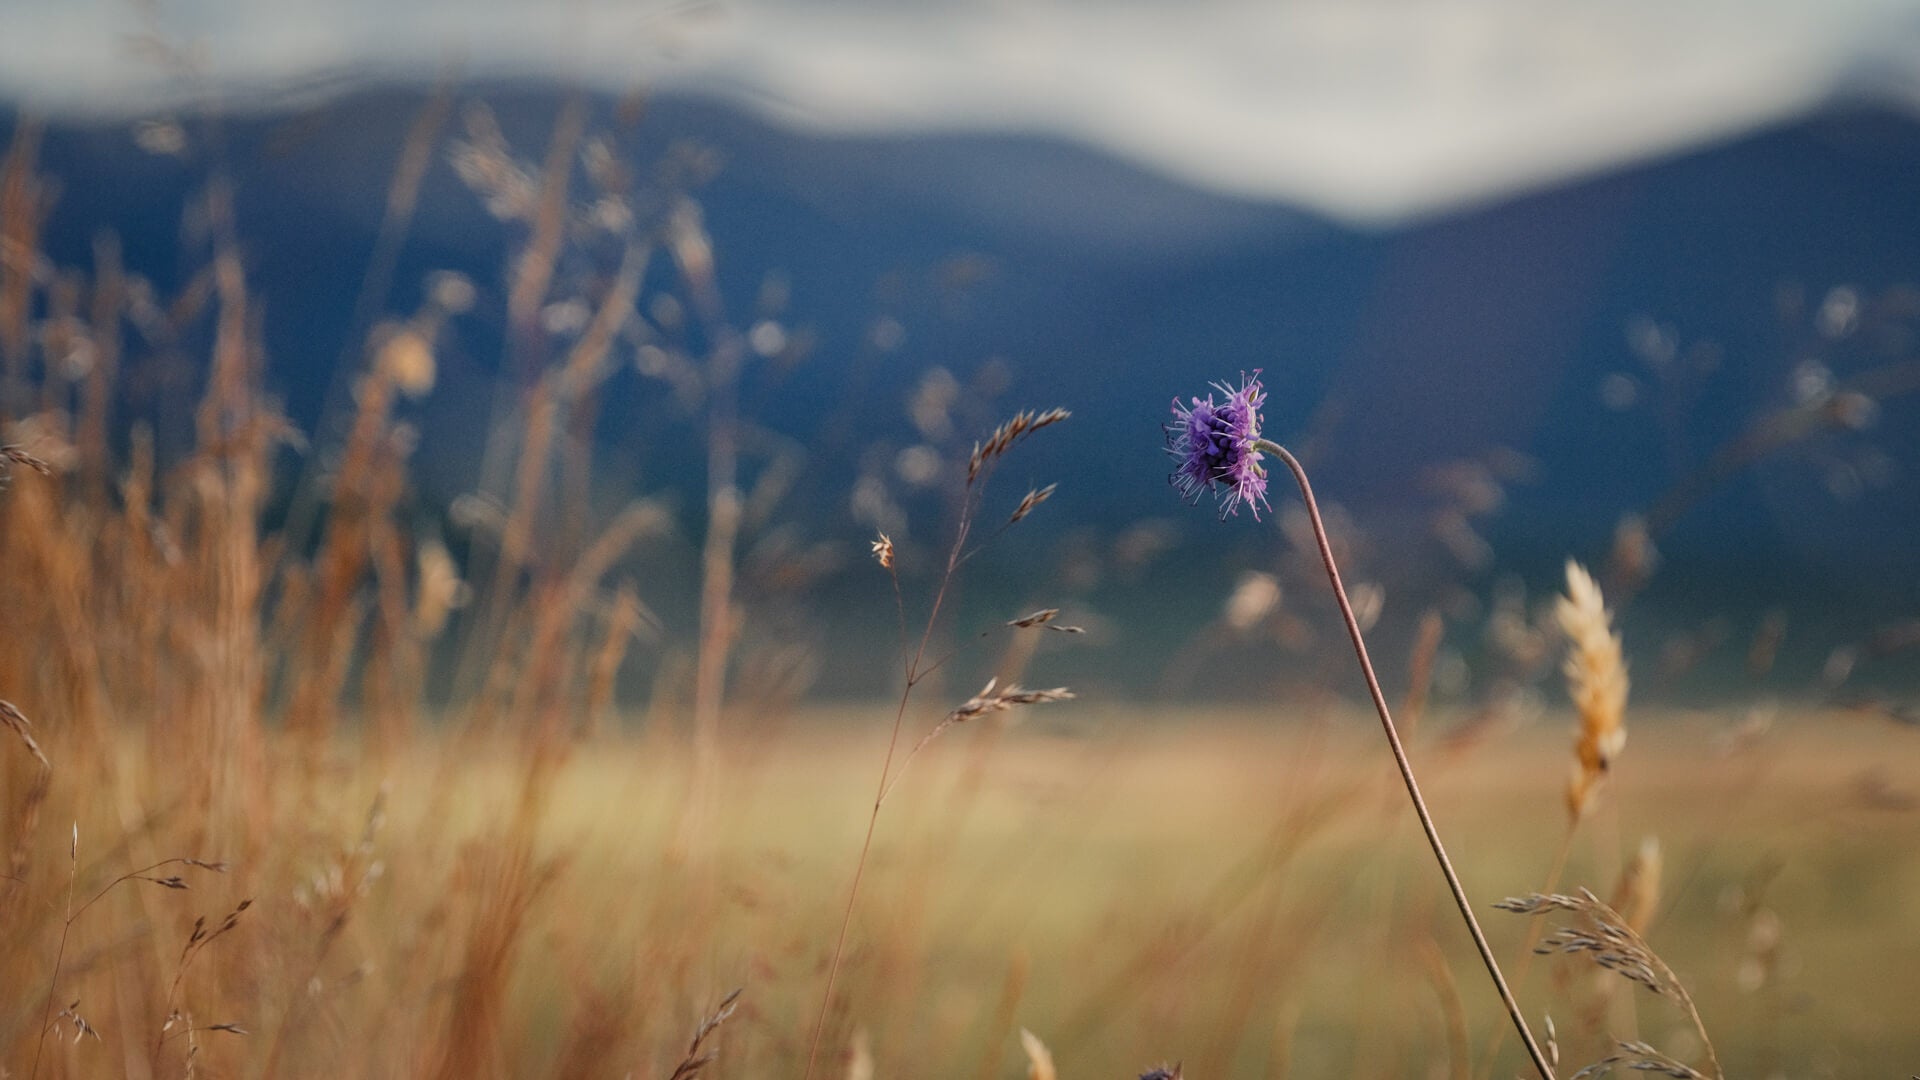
[0,0,1920,225]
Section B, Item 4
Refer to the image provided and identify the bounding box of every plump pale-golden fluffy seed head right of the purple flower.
[1553,559,1628,821]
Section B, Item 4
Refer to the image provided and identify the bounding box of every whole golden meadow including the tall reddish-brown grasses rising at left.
[0,98,1920,1080]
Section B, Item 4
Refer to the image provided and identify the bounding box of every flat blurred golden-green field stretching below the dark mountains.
[8,691,1920,1076]
